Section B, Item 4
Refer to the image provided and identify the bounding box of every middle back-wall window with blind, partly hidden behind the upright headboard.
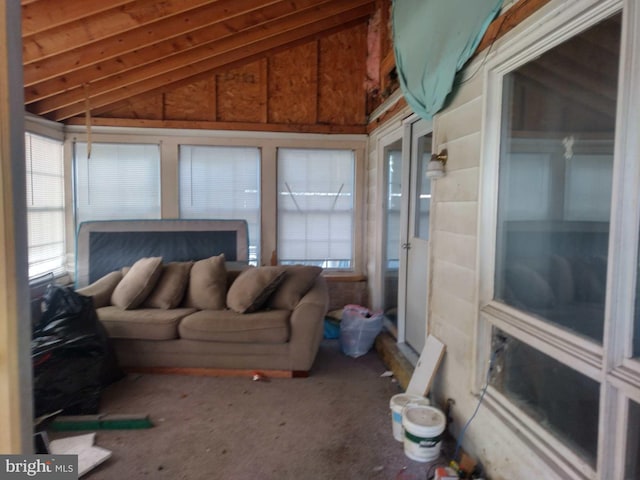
[179,145,260,265]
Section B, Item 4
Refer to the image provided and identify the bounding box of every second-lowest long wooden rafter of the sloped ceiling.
[30,0,372,115]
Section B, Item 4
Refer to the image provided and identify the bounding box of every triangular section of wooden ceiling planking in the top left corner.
[22,0,136,37]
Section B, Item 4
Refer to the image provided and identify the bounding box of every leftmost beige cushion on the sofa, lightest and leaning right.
[111,257,162,310]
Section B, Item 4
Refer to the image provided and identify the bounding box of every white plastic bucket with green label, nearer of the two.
[402,404,446,462]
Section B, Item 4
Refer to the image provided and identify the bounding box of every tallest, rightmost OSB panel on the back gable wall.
[318,25,367,125]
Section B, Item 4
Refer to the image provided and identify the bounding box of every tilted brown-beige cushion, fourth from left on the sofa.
[227,267,284,313]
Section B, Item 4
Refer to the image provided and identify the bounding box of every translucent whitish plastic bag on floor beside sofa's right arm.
[340,305,384,358]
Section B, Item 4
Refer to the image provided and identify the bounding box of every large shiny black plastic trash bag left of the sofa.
[31,285,122,417]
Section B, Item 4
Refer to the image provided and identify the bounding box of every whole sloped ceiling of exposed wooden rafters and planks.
[21,0,376,121]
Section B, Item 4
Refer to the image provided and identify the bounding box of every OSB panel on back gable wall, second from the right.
[268,42,318,124]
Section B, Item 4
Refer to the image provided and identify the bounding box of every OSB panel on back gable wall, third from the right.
[216,60,267,122]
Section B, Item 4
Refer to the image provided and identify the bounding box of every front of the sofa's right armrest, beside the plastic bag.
[290,275,329,371]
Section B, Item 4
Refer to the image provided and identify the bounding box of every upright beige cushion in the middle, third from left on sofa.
[184,254,227,310]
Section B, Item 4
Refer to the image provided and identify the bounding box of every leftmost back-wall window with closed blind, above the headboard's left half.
[74,143,160,225]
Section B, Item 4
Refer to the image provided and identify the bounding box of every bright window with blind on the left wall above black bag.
[25,133,65,278]
